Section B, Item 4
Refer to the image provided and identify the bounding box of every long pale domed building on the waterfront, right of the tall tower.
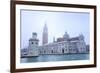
[39,32,86,54]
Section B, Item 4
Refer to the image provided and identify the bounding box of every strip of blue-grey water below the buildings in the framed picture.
[21,54,89,63]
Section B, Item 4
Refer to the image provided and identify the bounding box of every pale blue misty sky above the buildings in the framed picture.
[21,10,90,48]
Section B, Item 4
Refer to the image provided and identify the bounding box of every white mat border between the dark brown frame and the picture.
[15,4,94,69]
